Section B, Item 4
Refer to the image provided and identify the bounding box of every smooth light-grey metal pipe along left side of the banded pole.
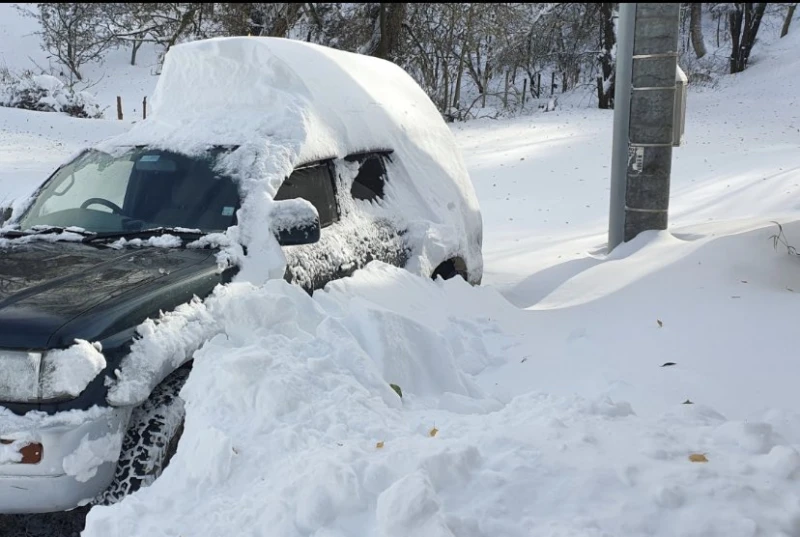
[608,4,637,251]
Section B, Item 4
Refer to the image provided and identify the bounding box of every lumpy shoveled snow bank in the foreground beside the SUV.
[83,263,800,537]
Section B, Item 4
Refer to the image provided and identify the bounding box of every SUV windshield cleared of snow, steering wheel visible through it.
[19,148,239,233]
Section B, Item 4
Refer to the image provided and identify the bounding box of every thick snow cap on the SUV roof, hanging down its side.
[94,37,482,283]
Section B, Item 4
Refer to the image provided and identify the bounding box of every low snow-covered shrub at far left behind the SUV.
[0,69,103,119]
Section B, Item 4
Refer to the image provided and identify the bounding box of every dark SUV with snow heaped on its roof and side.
[0,38,482,513]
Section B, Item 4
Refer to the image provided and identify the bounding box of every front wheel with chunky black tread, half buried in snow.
[93,366,189,505]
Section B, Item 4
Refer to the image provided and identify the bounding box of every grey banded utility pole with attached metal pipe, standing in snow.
[608,3,682,251]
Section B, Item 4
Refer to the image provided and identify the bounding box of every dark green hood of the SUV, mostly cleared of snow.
[0,242,220,349]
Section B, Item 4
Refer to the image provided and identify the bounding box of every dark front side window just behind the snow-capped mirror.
[275,160,339,227]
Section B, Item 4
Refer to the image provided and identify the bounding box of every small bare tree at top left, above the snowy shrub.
[20,3,116,83]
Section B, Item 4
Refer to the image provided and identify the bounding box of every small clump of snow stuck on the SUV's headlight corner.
[42,340,106,398]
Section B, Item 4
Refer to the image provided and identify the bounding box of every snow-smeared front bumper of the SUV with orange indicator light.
[0,408,131,514]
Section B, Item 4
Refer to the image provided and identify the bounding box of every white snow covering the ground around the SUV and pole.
[0,7,800,537]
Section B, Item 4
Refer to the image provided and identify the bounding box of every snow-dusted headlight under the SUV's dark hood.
[0,350,99,403]
